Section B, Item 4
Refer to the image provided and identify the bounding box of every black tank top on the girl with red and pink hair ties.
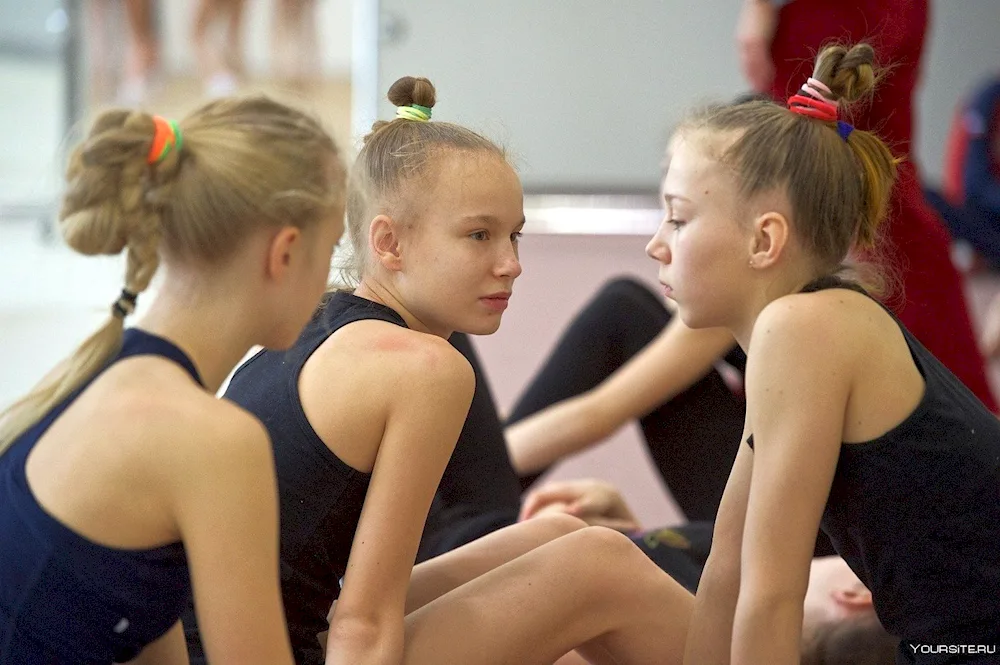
[747,279,1000,663]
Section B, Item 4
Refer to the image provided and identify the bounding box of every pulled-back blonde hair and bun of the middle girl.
[338,76,507,286]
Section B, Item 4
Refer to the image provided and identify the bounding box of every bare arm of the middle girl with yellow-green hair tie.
[326,340,475,665]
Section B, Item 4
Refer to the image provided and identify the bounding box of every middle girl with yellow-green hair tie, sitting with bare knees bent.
[182,77,693,665]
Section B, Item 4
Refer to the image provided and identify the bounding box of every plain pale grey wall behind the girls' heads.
[370,0,1000,191]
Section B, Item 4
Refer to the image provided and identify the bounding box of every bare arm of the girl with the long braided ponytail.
[176,402,292,665]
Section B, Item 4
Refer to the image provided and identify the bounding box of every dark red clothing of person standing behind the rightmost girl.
[771,0,997,412]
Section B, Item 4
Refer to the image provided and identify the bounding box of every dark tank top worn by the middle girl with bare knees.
[185,292,406,665]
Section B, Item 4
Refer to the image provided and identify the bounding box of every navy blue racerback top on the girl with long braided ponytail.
[0,328,203,665]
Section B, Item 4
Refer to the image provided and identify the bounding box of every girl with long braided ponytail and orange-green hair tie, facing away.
[0,97,345,665]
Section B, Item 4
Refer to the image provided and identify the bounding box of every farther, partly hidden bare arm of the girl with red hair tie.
[684,430,753,665]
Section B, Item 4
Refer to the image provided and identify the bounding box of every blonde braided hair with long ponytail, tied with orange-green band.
[0,96,344,454]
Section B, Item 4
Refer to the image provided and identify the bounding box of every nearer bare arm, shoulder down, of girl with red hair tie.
[732,296,856,665]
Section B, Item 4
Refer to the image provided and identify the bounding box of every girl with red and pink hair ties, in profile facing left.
[647,44,1000,664]
